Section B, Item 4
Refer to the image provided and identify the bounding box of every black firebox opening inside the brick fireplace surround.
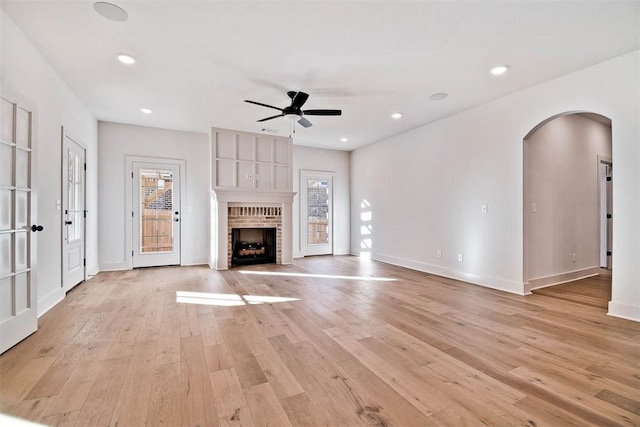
[231,228,276,266]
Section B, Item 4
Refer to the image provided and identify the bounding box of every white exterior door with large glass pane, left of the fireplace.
[132,162,180,268]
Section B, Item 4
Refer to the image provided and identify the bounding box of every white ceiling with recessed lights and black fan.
[3,0,640,150]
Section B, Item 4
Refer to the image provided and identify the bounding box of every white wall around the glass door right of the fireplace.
[293,145,351,258]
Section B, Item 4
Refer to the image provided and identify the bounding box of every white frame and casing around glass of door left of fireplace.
[124,156,186,268]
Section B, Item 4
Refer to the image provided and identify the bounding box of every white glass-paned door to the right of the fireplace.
[300,171,333,256]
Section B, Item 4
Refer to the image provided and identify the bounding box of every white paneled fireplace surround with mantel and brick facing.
[210,128,295,270]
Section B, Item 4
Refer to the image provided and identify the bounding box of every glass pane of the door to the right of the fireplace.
[307,179,329,245]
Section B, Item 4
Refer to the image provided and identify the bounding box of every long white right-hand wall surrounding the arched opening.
[351,51,640,320]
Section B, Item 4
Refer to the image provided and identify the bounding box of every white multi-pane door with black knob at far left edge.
[0,91,42,353]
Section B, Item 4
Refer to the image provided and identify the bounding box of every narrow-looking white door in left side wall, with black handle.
[62,129,86,292]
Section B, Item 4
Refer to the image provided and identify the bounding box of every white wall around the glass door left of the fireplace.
[98,122,209,270]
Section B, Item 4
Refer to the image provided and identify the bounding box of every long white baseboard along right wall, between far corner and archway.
[371,254,526,295]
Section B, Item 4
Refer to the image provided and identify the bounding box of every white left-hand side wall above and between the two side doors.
[0,9,98,315]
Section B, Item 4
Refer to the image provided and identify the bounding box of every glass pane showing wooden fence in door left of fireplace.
[139,169,173,253]
